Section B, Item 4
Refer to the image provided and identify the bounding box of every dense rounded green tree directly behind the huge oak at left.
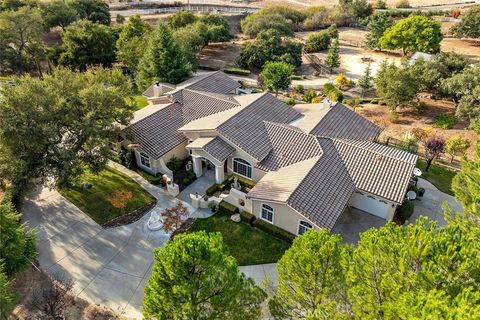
[59,20,117,71]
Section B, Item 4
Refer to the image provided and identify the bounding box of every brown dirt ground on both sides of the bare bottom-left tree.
[9,267,123,320]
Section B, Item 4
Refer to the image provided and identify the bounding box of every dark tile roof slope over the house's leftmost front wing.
[126,103,186,159]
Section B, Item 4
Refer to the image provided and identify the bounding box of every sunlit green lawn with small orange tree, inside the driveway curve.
[59,167,155,224]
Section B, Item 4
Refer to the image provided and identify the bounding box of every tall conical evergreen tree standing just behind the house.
[137,22,192,88]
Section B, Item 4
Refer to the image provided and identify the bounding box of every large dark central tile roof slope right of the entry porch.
[217,93,301,161]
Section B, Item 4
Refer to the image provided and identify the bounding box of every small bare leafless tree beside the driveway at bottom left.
[32,272,74,320]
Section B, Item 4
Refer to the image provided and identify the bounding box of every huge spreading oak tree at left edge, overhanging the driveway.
[0,68,134,195]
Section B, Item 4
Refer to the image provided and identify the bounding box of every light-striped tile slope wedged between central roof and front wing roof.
[257,121,322,171]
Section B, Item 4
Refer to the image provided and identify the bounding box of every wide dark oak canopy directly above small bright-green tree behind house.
[239,29,302,69]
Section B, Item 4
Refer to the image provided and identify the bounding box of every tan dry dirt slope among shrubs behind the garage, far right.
[357,99,478,157]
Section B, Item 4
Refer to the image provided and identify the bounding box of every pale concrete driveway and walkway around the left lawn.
[23,163,272,319]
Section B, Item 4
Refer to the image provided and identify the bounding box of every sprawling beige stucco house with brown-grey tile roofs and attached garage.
[126,72,417,234]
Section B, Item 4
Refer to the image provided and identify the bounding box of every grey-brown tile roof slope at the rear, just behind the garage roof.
[309,103,382,141]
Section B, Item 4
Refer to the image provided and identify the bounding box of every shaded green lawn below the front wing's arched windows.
[188,213,290,265]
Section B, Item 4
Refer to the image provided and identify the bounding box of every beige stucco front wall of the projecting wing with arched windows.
[248,199,318,234]
